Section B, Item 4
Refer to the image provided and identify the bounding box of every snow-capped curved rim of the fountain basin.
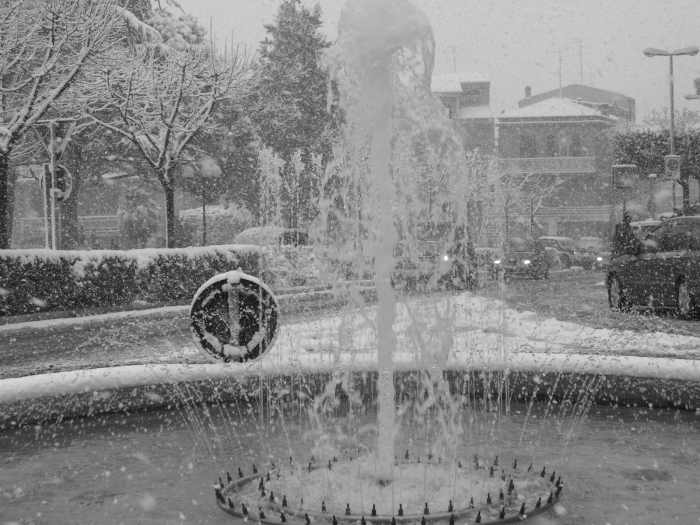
[0,353,700,406]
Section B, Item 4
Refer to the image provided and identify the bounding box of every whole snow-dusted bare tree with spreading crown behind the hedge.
[86,40,253,247]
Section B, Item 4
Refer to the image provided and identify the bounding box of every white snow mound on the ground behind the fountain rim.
[272,293,700,356]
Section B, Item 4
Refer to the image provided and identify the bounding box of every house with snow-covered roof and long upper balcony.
[497,95,616,239]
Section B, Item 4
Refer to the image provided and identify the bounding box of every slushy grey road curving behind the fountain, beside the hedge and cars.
[0,271,700,379]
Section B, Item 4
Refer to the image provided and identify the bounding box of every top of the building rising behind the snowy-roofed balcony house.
[518,84,637,122]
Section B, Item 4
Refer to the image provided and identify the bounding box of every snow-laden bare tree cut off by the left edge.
[0,0,144,249]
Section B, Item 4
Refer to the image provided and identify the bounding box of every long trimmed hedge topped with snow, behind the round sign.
[0,245,260,316]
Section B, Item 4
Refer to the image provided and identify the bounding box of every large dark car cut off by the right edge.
[607,217,700,316]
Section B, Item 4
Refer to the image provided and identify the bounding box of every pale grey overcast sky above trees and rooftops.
[178,0,700,120]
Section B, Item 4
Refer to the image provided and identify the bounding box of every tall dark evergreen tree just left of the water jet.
[252,0,339,227]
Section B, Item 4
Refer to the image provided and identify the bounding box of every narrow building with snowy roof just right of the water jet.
[431,74,496,153]
